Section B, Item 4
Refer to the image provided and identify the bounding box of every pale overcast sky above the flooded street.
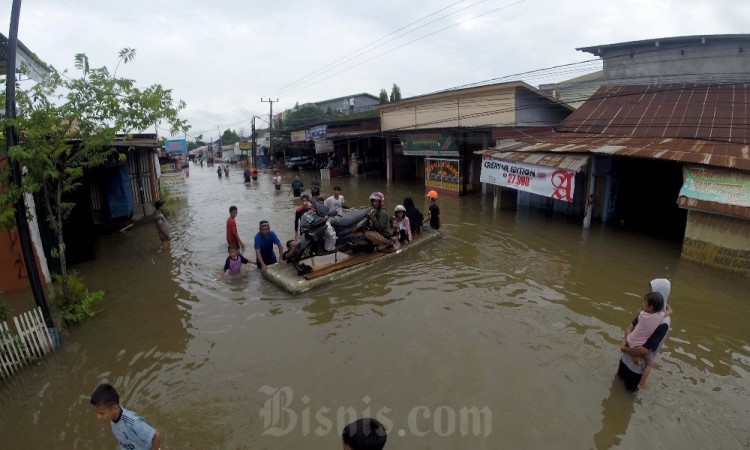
[0,0,750,139]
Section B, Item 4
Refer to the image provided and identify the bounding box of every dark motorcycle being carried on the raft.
[287,203,375,275]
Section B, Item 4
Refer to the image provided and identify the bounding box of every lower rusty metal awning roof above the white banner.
[477,133,750,171]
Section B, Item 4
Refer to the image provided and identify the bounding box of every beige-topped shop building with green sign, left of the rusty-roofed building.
[378,81,572,195]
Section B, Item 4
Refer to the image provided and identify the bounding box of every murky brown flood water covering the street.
[0,166,750,449]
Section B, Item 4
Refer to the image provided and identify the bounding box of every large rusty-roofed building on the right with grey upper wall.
[484,35,750,276]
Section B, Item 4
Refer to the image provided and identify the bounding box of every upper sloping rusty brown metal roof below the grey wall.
[558,83,750,144]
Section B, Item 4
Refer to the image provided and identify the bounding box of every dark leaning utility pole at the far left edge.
[5,0,55,328]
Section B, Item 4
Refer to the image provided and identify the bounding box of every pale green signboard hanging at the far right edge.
[680,167,750,207]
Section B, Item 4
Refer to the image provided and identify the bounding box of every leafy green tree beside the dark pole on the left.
[0,48,189,310]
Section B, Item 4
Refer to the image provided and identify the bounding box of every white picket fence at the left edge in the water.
[0,308,55,378]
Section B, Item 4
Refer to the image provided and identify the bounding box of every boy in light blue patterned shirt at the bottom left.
[91,384,161,450]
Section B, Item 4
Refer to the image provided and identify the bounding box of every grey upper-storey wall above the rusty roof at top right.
[600,40,750,84]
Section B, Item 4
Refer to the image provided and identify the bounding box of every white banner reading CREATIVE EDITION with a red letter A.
[480,159,576,202]
